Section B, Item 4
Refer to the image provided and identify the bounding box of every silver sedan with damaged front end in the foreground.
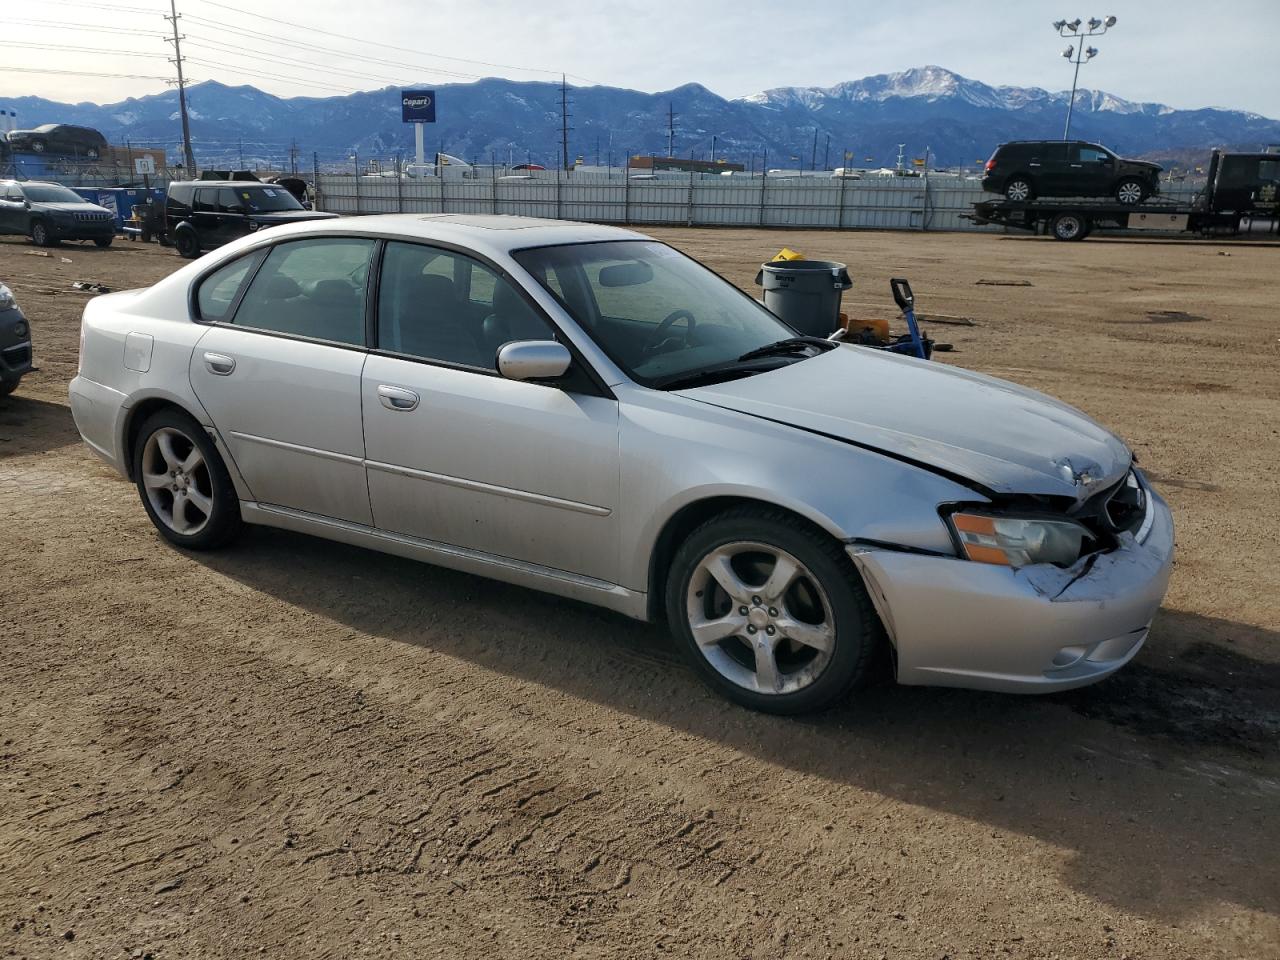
[70,215,1172,713]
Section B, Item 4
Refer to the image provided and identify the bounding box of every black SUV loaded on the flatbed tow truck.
[982,140,1161,204]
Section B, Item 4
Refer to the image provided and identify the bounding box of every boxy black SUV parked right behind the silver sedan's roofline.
[164,180,338,260]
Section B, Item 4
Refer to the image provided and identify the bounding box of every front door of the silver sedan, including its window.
[361,242,618,582]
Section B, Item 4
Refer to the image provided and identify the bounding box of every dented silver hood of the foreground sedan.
[680,344,1132,500]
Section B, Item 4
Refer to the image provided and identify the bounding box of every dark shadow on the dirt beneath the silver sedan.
[196,527,1280,920]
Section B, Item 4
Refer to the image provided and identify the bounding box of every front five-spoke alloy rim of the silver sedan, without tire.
[686,541,836,695]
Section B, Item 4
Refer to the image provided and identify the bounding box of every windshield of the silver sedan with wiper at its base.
[512,241,804,387]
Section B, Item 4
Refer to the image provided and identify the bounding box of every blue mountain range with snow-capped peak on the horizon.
[0,67,1280,169]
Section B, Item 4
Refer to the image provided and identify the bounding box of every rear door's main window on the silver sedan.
[231,237,374,346]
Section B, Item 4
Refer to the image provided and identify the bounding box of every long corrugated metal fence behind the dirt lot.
[316,173,1193,230]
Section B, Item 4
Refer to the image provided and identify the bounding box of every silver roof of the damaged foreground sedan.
[252,214,653,255]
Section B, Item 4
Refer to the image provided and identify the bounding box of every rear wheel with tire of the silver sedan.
[133,408,242,550]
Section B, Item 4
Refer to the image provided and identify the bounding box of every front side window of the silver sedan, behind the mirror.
[378,242,554,370]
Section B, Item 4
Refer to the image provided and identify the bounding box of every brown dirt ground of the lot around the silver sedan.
[0,229,1280,960]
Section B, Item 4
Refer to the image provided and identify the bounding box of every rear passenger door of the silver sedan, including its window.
[191,237,375,525]
